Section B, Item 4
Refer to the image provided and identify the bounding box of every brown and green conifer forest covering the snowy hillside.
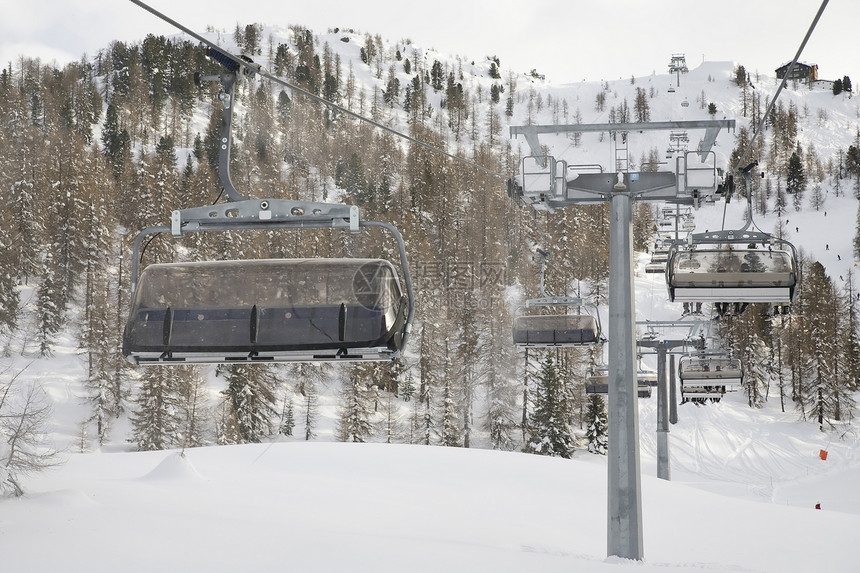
[0,25,860,470]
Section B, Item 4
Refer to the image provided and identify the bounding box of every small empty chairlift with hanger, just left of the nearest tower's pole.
[512,249,602,348]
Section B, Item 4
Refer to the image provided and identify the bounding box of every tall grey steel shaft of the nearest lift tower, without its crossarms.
[607,179,644,560]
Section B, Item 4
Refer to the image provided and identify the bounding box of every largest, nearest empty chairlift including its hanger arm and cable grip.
[122,50,414,365]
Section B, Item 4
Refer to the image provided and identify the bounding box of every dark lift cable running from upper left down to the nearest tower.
[124,0,509,181]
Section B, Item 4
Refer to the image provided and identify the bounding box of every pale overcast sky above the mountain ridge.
[0,0,860,85]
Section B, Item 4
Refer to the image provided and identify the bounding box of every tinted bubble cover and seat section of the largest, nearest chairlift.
[123,259,407,364]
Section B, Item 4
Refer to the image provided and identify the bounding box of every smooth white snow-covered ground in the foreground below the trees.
[0,404,860,573]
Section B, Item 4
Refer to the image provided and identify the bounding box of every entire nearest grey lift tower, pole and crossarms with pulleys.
[508,116,735,560]
